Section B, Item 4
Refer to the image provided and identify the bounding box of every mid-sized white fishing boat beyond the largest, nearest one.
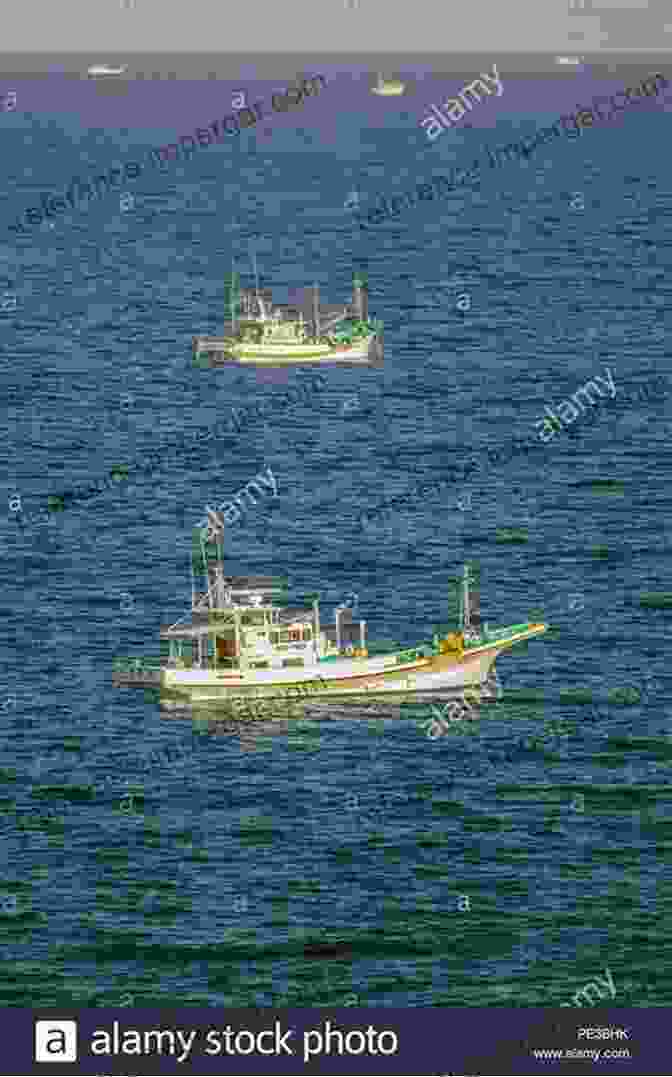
[193,265,382,364]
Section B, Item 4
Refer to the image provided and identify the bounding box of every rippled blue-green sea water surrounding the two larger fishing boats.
[0,67,672,1007]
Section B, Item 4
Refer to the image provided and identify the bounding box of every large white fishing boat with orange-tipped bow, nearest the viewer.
[117,519,547,709]
